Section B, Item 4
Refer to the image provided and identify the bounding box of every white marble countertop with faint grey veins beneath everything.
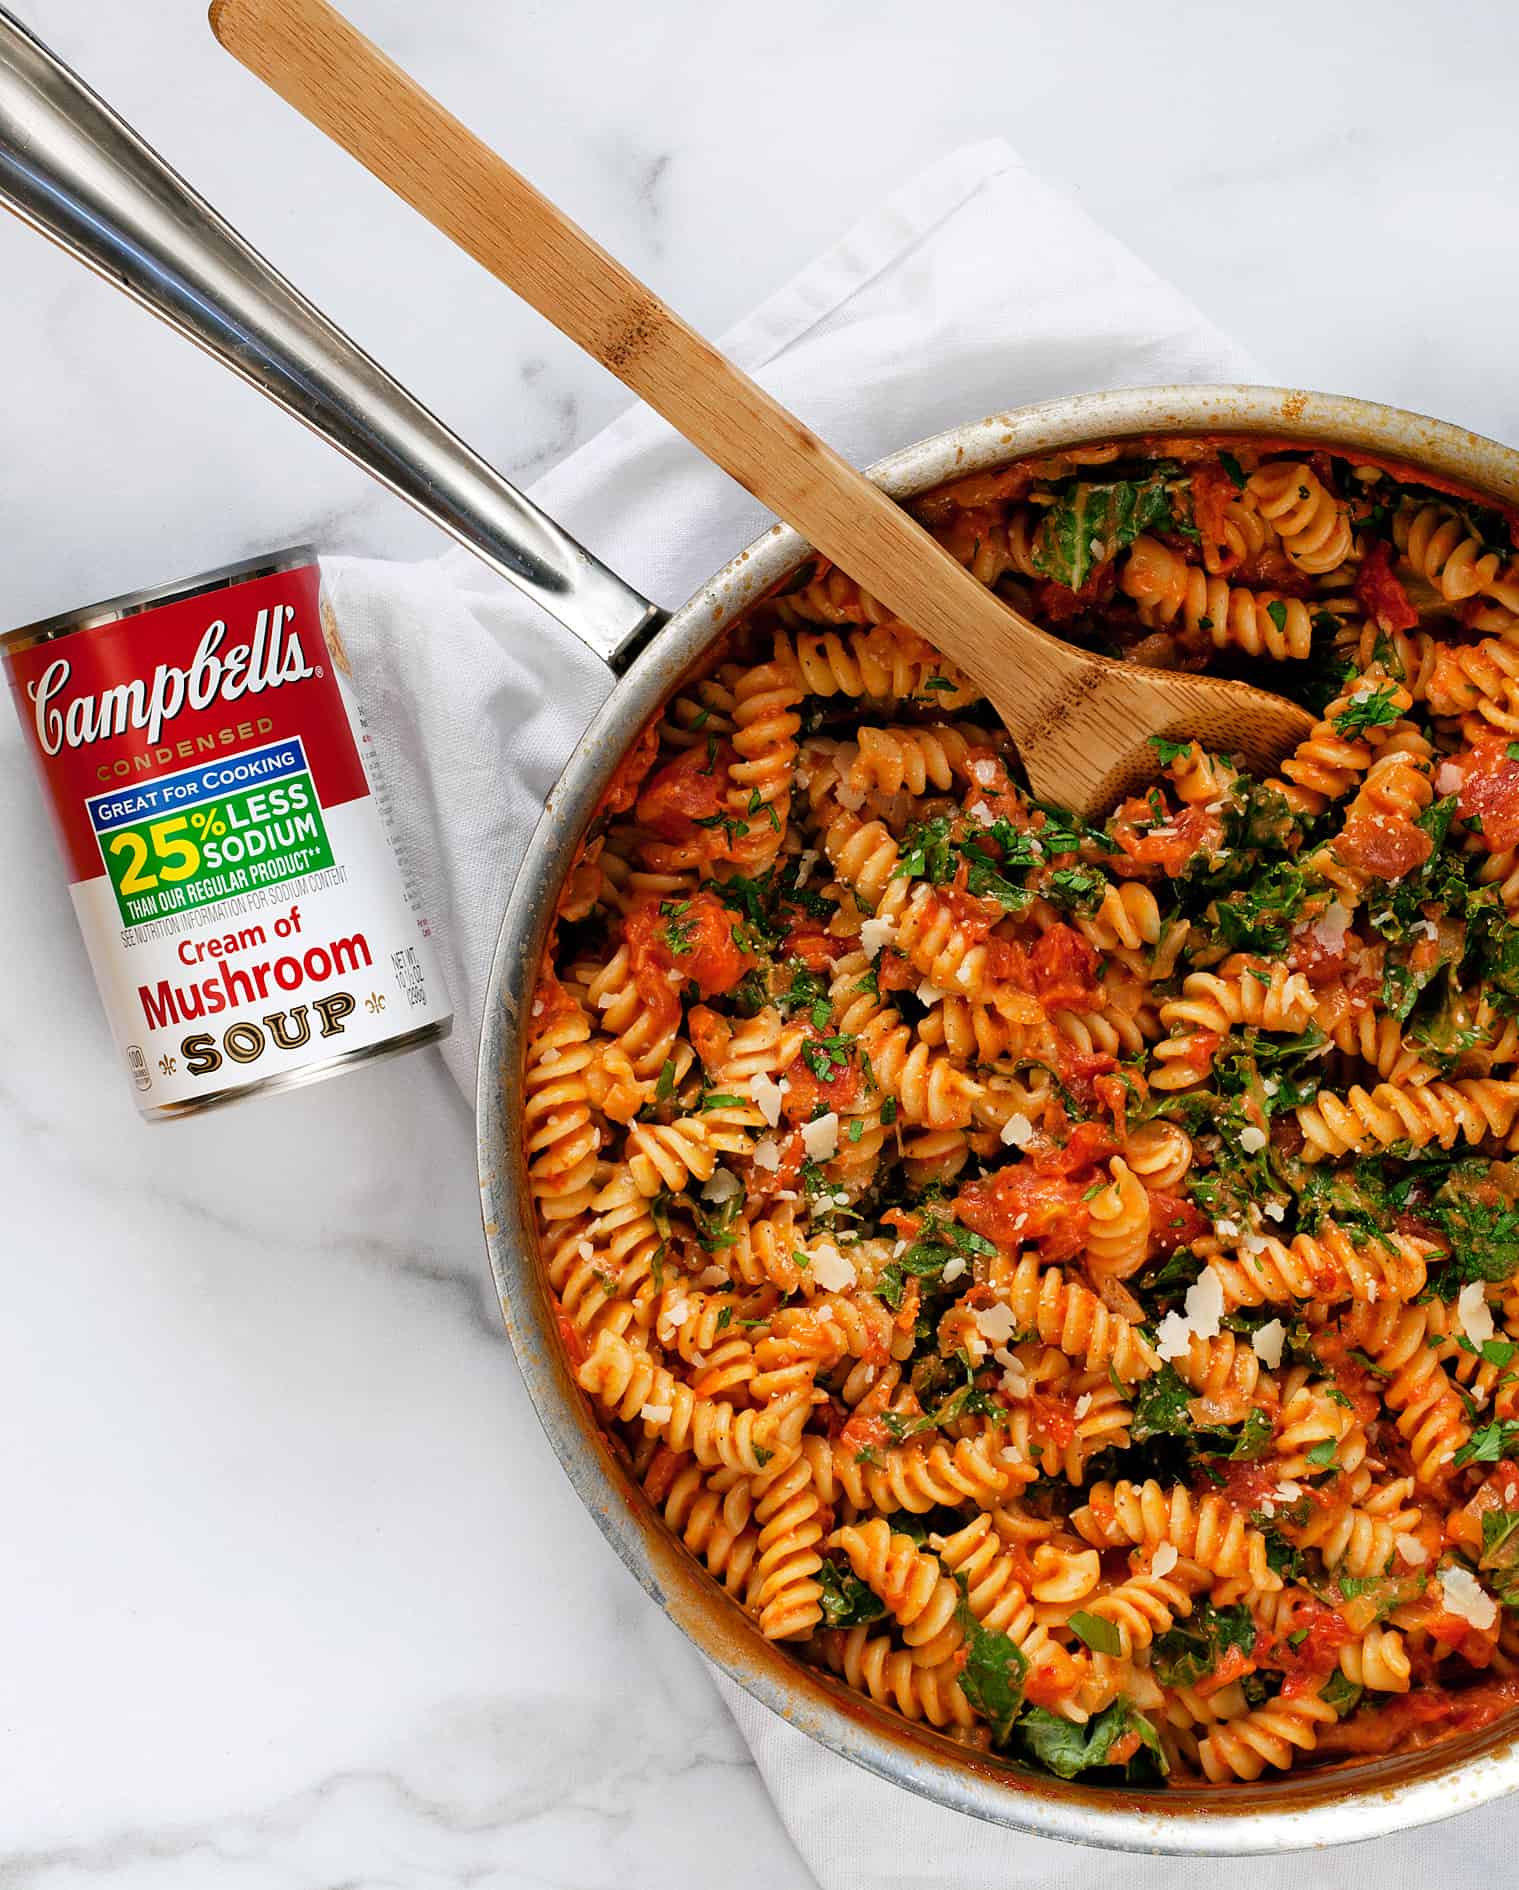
[0,0,1519,1890]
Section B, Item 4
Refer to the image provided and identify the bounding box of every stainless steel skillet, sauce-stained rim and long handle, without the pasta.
[0,11,1519,1854]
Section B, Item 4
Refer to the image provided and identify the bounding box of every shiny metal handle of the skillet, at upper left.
[0,8,665,667]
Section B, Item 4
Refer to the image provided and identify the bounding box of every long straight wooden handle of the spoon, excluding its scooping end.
[212,0,1073,714]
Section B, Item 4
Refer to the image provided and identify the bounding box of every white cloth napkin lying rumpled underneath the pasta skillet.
[327,144,1519,1890]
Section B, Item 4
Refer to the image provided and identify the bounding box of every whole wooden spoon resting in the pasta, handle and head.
[212,0,1311,813]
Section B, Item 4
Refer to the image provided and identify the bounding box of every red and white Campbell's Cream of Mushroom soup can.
[2,548,452,1117]
